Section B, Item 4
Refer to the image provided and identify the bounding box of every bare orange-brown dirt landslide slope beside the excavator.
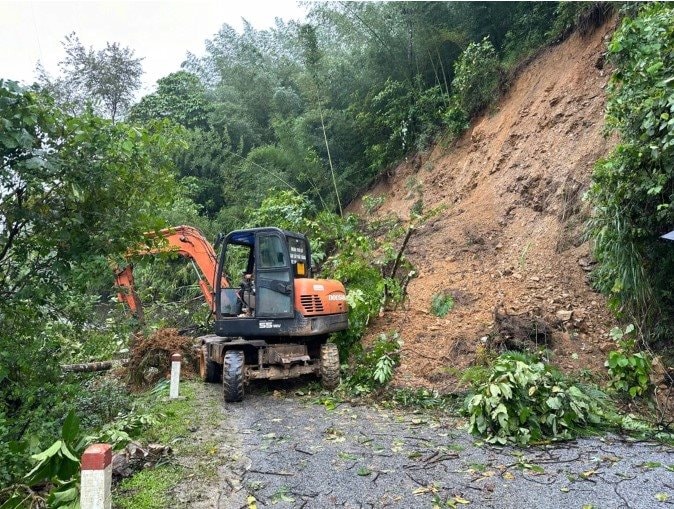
[352,23,613,390]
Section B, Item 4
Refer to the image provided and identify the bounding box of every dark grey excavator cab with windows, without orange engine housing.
[215,228,311,319]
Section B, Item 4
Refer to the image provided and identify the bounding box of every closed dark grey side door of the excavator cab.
[255,232,295,318]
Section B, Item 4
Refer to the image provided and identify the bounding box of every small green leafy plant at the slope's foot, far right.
[604,324,651,398]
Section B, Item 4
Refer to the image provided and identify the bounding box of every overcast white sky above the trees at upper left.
[0,0,305,92]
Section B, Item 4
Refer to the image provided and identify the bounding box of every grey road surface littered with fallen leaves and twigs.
[174,385,674,509]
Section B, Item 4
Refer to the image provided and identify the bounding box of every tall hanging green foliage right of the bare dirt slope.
[588,3,674,341]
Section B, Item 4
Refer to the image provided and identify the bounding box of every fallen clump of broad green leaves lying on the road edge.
[465,353,607,445]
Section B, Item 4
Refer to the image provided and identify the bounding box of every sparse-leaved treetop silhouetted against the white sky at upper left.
[37,32,143,122]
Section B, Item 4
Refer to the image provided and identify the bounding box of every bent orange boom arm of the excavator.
[115,225,224,318]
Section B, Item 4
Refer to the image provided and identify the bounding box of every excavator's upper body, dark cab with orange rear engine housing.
[214,228,348,341]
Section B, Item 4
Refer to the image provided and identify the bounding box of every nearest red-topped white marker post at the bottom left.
[80,444,112,509]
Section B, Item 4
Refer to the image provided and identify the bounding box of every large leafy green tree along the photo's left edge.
[0,80,180,482]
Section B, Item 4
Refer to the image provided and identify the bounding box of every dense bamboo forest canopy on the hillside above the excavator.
[128,2,579,227]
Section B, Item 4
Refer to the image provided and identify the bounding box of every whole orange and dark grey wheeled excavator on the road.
[115,225,348,402]
